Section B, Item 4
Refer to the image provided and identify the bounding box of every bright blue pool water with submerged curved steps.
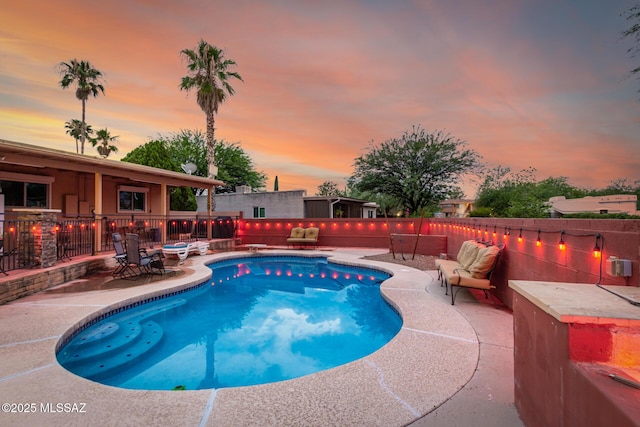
[57,256,402,390]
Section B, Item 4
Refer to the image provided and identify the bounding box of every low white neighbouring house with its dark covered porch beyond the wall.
[198,185,378,218]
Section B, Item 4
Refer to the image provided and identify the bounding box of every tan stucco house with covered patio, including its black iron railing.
[0,139,223,263]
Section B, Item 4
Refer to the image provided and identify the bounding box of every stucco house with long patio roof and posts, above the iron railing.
[0,139,224,250]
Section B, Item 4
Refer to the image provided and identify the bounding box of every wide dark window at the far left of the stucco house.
[0,172,54,209]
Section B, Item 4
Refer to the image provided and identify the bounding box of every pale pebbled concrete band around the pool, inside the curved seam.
[0,250,479,426]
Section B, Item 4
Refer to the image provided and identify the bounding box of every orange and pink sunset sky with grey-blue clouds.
[0,0,640,197]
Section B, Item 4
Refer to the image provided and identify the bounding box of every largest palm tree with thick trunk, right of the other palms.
[180,39,243,209]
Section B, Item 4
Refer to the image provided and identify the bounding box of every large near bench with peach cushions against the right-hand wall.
[436,240,504,305]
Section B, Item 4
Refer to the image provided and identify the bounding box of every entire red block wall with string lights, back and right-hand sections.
[238,218,640,307]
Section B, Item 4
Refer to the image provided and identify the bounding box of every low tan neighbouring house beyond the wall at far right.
[548,194,638,218]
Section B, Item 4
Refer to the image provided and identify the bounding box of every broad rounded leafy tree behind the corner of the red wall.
[349,126,482,213]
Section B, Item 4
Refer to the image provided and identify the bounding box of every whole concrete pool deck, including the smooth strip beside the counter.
[0,249,522,426]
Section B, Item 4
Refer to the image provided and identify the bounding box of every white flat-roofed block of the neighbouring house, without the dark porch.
[205,185,306,218]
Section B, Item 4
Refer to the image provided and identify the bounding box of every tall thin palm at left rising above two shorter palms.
[58,59,104,154]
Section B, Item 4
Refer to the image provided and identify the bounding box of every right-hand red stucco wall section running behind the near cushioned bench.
[429,218,640,308]
